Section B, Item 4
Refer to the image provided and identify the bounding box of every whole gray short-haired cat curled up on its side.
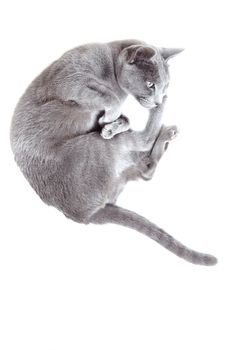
[11,40,217,265]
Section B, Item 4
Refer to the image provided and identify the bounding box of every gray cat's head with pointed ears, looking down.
[118,45,183,108]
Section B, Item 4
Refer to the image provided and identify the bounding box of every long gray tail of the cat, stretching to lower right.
[90,204,217,266]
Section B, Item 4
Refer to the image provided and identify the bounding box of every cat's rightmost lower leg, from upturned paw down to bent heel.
[141,125,178,180]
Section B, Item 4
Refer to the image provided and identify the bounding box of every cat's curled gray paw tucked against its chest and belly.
[100,115,130,139]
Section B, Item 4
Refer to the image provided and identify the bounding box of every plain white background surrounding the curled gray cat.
[0,0,233,350]
